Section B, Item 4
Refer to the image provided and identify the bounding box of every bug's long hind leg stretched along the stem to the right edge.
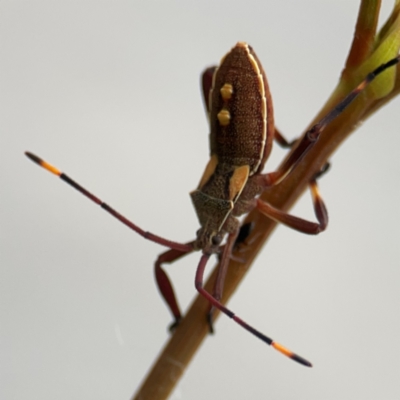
[263,56,400,186]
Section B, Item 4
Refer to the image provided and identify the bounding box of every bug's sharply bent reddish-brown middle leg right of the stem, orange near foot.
[255,164,329,235]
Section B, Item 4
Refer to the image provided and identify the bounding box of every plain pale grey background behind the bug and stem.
[0,1,400,400]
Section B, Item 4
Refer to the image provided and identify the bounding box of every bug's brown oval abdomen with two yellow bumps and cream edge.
[210,43,273,175]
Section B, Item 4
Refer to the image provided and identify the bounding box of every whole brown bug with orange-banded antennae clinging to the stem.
[26,42,400,367]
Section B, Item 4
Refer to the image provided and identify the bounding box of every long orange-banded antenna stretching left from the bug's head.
[25,151,193,252]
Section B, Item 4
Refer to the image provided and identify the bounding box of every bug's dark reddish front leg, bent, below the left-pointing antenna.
[154,242,193,331]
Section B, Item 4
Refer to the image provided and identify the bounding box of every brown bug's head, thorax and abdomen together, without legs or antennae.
[191,43,273,253]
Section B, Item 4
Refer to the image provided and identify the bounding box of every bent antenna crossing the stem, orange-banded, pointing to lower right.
[195,254,312,367]
